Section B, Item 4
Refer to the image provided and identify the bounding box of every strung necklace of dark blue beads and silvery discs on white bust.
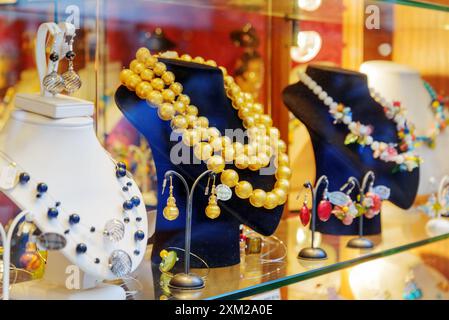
[0,151,145,277]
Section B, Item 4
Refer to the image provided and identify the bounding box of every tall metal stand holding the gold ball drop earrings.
[162,170,212,290]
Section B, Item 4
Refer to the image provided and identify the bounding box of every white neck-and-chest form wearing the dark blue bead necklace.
[0,110,148,279]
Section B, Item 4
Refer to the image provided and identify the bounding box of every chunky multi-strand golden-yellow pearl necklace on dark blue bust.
[120,48,291,209]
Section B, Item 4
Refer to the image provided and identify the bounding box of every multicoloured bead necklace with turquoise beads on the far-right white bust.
[416,81,449,148]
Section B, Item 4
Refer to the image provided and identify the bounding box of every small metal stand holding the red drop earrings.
[298,176,329,260]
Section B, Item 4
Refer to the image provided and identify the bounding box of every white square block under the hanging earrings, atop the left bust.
[15,93,94,119]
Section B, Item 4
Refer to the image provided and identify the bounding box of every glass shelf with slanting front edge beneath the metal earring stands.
[130,202,449,299]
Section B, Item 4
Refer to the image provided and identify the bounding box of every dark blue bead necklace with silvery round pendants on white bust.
[0,151,145,277]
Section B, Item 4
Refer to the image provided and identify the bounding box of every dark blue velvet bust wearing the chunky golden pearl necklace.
[115,59,283,267]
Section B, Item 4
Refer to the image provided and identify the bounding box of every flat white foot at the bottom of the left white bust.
[10,279,126,300]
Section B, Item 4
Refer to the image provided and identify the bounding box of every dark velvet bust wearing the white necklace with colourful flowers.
[283,66,419,235]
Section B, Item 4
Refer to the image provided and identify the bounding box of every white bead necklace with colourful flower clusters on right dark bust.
[299,73,421,172]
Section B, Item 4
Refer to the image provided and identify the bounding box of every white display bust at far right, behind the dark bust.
[360,61,449,195]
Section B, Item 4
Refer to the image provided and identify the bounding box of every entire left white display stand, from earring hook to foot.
[0,23,151,299]
